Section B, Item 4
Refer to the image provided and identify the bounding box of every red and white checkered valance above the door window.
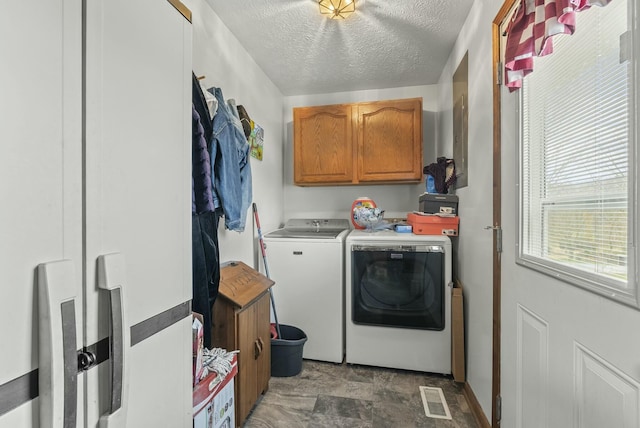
[505,0,611,91]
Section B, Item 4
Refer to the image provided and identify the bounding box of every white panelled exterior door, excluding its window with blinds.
[501,0,640,428]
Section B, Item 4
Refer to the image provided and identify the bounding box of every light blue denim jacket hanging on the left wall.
[209,88,253,232]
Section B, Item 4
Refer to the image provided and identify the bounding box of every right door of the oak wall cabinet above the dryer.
[357,98,423,182]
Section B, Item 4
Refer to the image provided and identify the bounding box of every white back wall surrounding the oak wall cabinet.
[283,85,438,219]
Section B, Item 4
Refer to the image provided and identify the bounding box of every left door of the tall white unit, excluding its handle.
[0,0,82,428]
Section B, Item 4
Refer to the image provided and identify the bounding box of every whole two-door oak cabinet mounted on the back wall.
[293,98,423,186]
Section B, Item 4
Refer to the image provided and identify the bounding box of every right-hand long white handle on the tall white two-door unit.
[98,253,131,428]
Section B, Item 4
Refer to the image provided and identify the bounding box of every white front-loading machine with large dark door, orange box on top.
[345,230,453,374]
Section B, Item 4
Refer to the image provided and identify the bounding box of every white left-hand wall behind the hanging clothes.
[184,0,283,267]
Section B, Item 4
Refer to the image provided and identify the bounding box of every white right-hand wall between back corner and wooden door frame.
[437,0,502,419]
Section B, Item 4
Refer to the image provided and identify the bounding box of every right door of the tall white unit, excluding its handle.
[84,0,192,427]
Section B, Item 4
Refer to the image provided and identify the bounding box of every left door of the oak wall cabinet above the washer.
[293,104,354,185]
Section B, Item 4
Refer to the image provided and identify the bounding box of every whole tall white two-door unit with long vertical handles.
[0,0,192,428]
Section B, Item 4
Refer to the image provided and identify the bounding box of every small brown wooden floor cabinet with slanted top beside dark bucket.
[212,262,274,426]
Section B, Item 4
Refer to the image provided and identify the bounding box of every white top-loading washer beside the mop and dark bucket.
[263,219,350,363]
